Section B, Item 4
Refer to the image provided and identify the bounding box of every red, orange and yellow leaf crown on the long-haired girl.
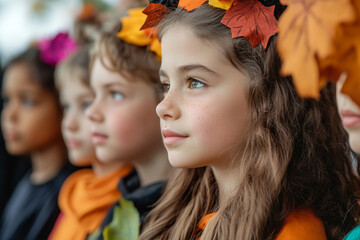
[141,0,284,48]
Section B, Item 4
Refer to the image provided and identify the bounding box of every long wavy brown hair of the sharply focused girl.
[139,4,359,240]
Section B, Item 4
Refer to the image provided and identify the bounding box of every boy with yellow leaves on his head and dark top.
[87,8,172,240]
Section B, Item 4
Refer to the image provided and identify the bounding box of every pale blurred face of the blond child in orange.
[60,76,96,166]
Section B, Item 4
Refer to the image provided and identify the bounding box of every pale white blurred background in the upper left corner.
[0,0,119,66]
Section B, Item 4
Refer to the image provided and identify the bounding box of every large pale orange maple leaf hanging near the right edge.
[277,0,354,98]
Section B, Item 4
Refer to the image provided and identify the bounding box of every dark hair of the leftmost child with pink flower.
[5,46,60,109]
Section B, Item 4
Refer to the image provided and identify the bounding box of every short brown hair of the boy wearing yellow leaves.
[90,23,161,98]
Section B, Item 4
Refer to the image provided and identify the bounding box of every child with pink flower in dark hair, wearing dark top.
[0,33,74,239]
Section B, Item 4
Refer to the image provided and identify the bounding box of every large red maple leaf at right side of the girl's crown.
[221,0,278,48]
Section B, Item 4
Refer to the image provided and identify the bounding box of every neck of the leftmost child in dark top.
[30,140,66,184]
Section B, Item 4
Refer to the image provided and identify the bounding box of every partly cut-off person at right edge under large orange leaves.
[278,0,360,240]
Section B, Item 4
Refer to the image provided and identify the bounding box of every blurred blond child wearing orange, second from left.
[49,45,132,240]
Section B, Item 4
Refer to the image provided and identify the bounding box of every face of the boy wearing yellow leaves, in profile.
[86,58,161,162]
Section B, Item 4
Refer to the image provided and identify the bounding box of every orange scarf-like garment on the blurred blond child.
[49,167,132,240]
